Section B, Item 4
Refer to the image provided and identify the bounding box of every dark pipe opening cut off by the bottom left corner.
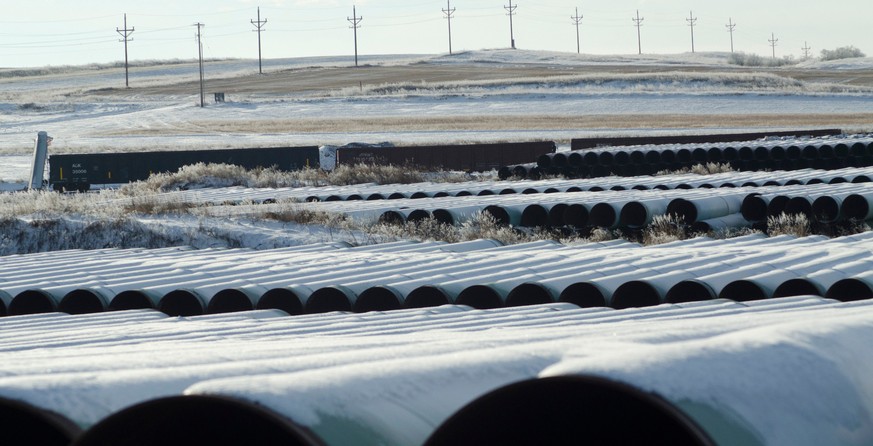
[0,398,81,446]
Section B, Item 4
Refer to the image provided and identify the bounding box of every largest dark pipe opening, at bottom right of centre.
[424,376,715,446]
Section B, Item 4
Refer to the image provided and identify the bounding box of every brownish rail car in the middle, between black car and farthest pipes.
[337,141,556,172]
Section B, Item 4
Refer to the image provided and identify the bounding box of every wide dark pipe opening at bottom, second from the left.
[73,395,324,446]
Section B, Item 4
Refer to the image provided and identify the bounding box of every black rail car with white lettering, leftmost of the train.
[49,146,319,191]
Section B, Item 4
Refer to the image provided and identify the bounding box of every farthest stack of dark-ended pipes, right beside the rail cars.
[498,135,873,179]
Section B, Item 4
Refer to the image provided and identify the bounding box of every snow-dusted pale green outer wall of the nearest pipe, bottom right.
[540,310,873,445]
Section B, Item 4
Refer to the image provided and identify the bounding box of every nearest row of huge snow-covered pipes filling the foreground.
[0,296,873,446]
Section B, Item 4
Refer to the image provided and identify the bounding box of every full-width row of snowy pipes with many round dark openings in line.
[0,232,873,316]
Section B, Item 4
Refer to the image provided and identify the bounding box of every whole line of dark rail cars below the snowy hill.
[34,129,841,191]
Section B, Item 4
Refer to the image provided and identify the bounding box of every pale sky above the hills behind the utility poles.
[0,0,873,67]
